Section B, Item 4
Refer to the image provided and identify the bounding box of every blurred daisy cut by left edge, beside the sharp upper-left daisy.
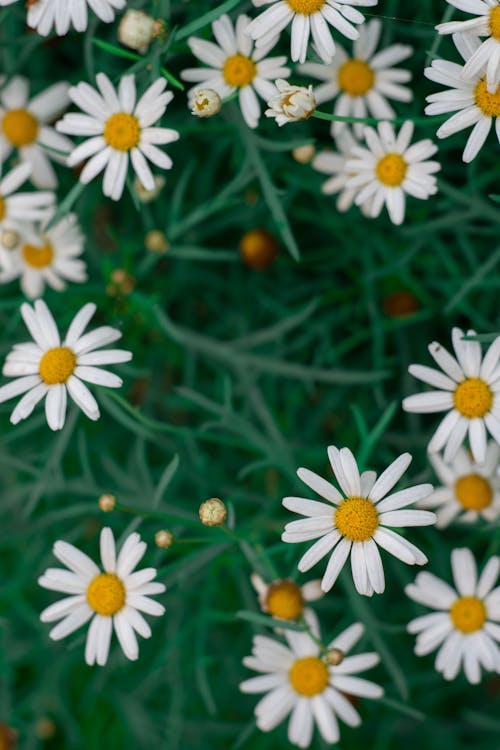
[0,76,73,188]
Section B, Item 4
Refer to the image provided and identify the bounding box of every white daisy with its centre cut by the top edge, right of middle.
[248,0,378,63]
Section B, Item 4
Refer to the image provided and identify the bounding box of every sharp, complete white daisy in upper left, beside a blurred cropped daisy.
[56,73,179,200]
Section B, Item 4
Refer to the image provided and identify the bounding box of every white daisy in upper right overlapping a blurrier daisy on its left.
[346,120,441,225]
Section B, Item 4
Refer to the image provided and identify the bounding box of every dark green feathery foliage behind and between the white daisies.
[0,0,500,750]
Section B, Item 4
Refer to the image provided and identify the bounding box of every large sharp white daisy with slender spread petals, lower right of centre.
[281,445,436,596]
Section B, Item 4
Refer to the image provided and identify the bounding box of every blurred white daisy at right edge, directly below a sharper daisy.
[418,441,500,529]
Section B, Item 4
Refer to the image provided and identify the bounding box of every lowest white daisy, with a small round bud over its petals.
[240,610,384,747]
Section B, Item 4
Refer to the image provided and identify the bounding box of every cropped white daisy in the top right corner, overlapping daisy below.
[436,0,500,94]
